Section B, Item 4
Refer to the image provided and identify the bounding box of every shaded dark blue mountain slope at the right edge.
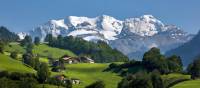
[166,32,200,65]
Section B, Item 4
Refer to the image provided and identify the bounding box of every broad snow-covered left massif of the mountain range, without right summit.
[30,15,123,41]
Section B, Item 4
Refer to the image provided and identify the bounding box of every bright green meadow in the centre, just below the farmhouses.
[54,63,122,88]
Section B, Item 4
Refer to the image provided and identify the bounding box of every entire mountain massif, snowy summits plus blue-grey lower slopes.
[29,15,192,58]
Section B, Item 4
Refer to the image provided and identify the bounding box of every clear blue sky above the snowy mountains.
[0,0,200,33]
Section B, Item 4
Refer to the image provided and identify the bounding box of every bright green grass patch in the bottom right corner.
[172,80,200,88]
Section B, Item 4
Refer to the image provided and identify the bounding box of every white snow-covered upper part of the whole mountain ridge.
[29,15,189,41]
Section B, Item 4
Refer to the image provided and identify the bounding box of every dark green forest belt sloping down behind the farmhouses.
[45,34,128,62]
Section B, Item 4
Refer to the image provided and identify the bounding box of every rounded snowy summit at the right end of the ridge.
[124,15,166,36]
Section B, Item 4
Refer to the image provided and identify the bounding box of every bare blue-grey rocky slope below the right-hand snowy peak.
[110,25,193,59]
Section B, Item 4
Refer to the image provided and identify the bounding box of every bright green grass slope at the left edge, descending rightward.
[0,54,35,73]
